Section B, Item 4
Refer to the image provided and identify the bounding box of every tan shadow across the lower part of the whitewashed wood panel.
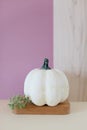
[65,72,87,101]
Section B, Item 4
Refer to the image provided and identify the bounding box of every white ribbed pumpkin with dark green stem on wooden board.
[24,58,69,106]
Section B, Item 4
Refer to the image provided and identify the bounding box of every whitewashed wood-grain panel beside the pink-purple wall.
[54,0,87,101]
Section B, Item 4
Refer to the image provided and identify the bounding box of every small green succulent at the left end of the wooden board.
[8,95,30,109]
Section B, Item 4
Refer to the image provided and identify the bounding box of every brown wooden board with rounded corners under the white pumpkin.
[13,101,70,115]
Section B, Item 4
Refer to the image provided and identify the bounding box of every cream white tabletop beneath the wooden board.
[0,100,87,130]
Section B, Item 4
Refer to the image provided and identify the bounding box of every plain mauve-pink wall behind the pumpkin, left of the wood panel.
[0,0,53,99]
